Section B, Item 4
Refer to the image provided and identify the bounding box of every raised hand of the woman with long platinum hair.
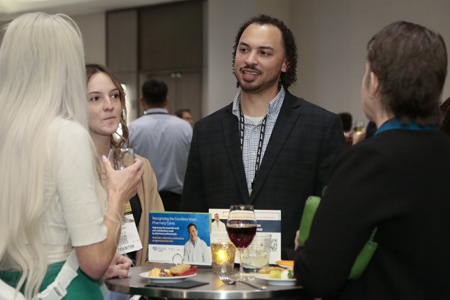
[102,156,144,204]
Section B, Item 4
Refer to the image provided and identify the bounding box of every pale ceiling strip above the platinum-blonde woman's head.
[0,0,184,21]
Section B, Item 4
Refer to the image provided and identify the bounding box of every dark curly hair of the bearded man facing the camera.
[233,15,298,89]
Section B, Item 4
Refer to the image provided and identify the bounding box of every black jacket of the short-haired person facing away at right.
[294,129,450,300]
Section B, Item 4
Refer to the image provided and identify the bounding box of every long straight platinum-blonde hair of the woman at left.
[0,13,106,299]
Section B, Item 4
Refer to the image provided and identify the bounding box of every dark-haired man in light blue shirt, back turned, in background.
[129,79,192,211]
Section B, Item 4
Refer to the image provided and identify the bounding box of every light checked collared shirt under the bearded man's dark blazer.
[232,87,286,192]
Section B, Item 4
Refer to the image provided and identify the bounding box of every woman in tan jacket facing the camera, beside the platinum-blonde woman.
[86,64,164,266]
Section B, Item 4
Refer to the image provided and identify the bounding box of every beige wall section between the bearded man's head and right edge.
[291,0,450,124]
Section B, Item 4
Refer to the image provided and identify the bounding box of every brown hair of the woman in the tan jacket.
[86,64,128,148]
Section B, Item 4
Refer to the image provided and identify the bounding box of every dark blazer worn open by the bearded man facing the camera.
[181,91,345,259]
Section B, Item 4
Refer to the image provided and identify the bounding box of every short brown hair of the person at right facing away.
[367,21,447,125]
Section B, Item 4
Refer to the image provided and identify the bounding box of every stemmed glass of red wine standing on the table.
[227,204,256,281]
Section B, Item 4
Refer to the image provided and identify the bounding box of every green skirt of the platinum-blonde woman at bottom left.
[0,262,103,300]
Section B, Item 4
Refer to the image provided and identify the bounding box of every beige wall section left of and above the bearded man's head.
[203,0,291,116]
